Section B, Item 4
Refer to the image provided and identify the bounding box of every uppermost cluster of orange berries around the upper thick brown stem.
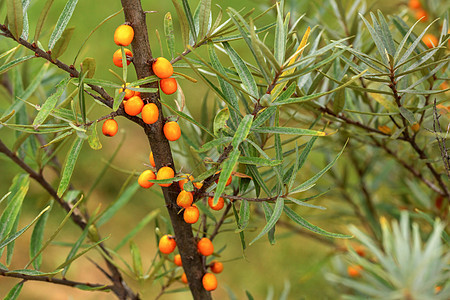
[102,24,181,141]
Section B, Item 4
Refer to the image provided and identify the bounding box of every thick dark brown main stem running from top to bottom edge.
[121,0,211,299]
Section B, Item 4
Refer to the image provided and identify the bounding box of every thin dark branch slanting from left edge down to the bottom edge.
[0,140,139,300]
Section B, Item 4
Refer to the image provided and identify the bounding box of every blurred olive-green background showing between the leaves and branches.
[0,0,403,300]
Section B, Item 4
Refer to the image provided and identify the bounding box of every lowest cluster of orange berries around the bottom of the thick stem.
[159,234,223,291]
